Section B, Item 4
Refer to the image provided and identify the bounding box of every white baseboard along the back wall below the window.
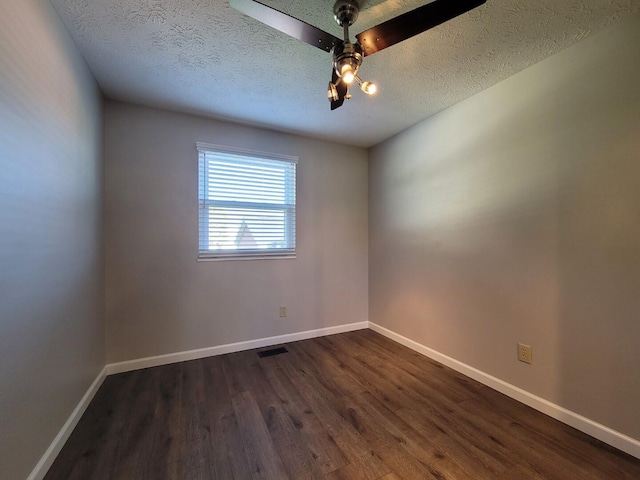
[105,322,369,375]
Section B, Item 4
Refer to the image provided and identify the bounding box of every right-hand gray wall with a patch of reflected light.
[369,11,640,438]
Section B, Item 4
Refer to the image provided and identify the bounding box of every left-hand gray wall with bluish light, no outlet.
[0,0,105,480]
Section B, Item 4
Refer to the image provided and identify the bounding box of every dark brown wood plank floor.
[46,330,640,480]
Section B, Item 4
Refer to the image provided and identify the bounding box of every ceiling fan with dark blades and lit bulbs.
[229,0,486,110]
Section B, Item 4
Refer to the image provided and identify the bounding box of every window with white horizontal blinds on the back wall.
[196,143,298,259]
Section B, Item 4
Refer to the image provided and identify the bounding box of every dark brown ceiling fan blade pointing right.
[356,0,486,56]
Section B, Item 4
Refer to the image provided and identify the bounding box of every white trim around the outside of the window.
[196,142,298,261]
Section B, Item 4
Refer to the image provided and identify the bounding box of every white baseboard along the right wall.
[369,322,640,458]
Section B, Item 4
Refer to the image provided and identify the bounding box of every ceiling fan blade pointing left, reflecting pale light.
[229,0,341,52]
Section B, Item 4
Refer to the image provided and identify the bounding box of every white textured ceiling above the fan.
[51,0,640,146]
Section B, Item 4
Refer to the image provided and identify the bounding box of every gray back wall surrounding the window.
[105,101,368,362]
